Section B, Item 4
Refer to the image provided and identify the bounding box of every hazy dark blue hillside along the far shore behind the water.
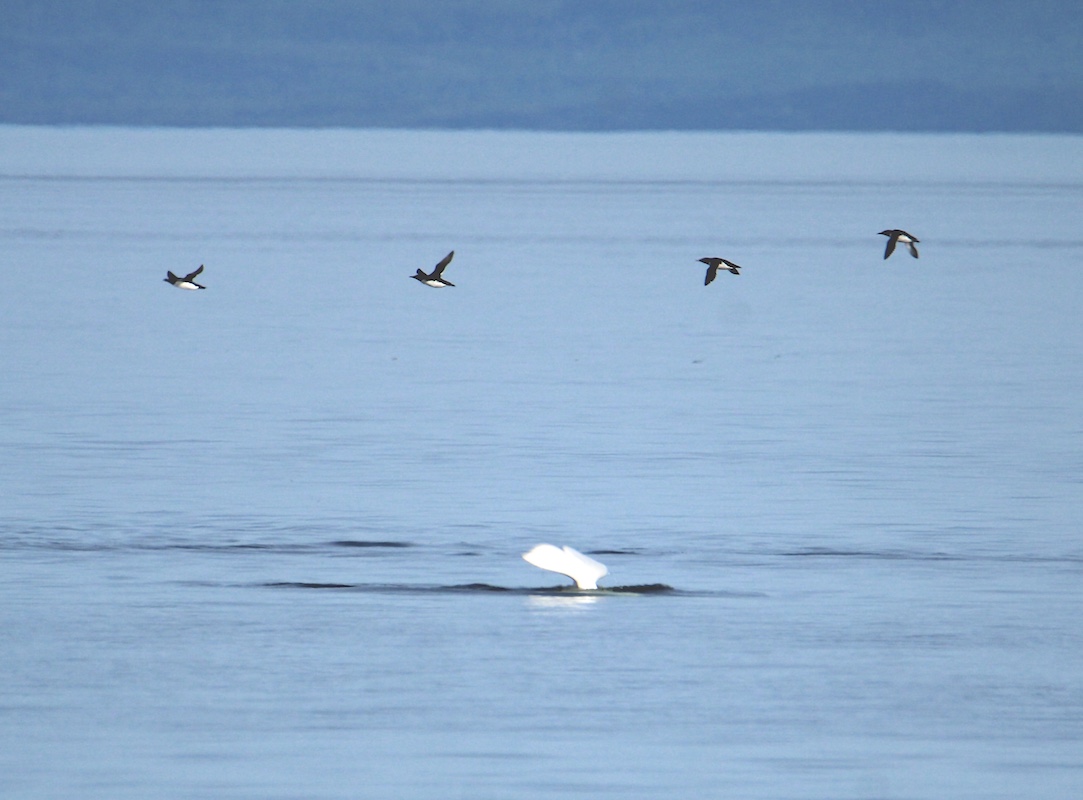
[0,0,1083,132]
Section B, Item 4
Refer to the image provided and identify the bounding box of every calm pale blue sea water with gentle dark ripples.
[0,128,1083,799]
